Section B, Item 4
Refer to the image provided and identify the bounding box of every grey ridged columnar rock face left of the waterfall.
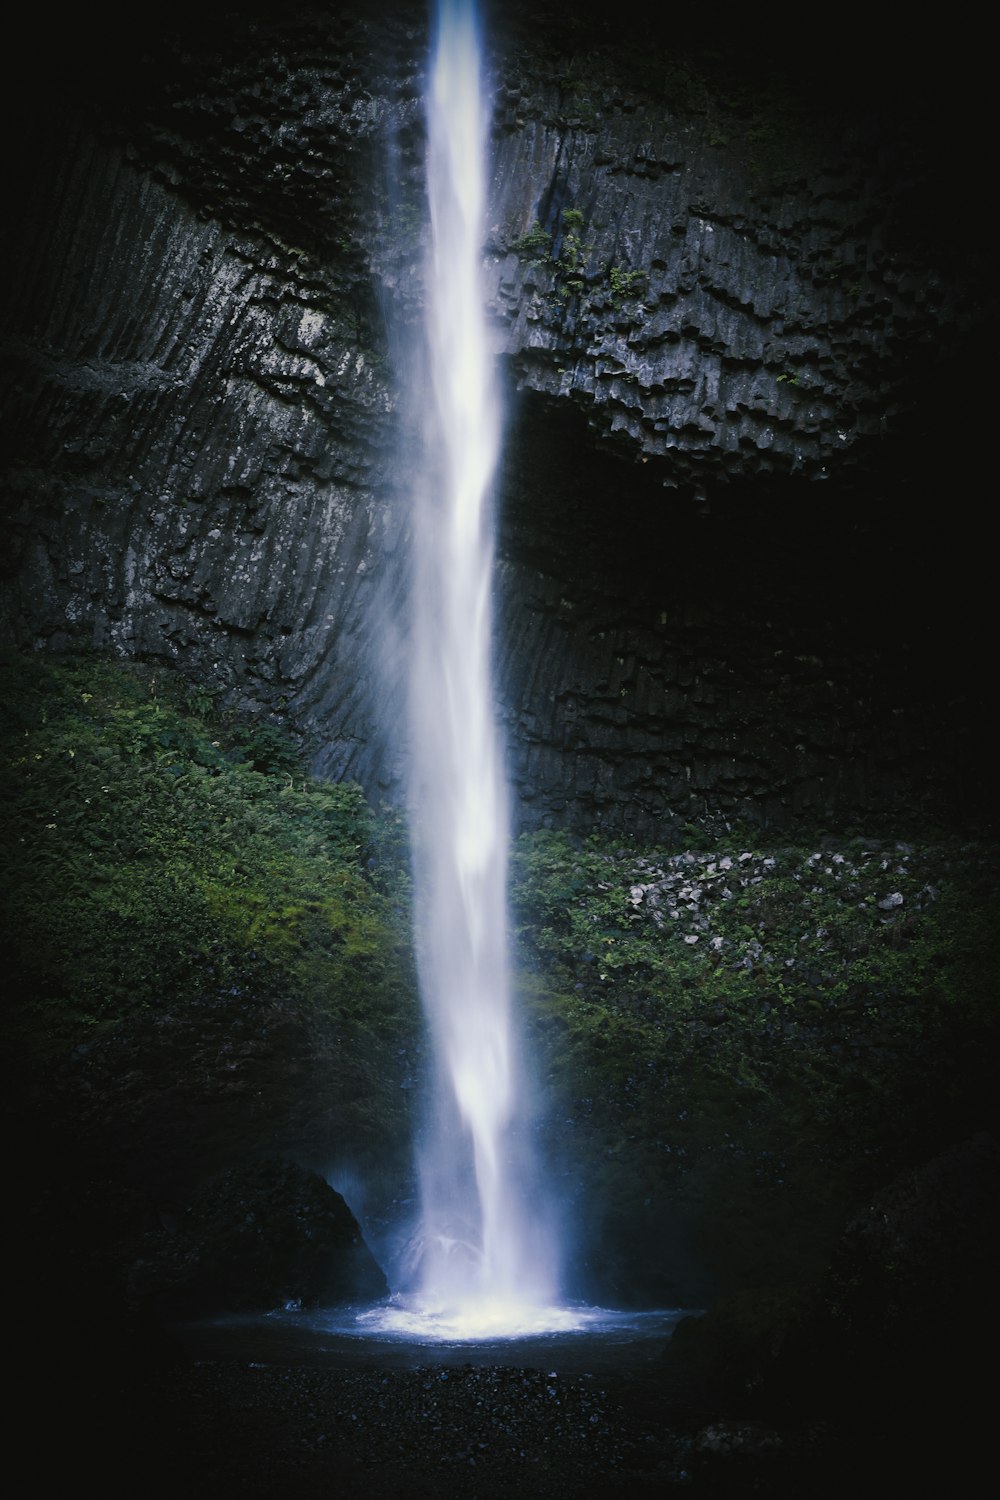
[4,32,401,774]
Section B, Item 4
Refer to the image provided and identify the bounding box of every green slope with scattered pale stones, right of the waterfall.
[514,831,999,1283]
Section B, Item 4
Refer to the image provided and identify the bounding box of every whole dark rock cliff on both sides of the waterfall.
[3,3,996,833]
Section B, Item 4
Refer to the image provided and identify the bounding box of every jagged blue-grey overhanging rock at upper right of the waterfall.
[489,58,941,494]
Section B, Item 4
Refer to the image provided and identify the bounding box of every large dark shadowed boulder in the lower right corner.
[661,1133,1000,1494]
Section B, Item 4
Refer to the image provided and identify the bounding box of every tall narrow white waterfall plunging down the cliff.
[392,0,558,1332]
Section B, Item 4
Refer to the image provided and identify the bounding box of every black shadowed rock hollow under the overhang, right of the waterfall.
[501,393,985,831]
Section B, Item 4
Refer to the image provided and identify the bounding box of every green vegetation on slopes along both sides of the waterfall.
[0,656,1000,1290]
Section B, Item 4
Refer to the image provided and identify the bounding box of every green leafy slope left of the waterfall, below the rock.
[0,657,417,1170]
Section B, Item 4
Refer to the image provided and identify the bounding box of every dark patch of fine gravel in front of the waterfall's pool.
[160,1362,690,1500]
